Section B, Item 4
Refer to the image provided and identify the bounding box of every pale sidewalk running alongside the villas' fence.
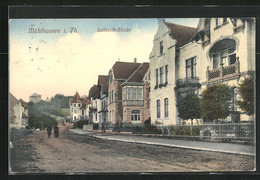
[70,129,255,156]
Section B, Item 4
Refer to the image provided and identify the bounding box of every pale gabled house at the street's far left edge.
[9,93,28,129]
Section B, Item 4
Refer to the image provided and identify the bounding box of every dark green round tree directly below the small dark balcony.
[177,93,201,124]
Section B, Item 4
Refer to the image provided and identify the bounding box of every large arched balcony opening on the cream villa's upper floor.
[209,39,236,69]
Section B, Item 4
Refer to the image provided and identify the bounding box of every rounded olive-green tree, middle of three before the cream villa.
[201,84,231,121]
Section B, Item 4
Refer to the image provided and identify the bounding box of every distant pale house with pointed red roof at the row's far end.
[69,92,90,122]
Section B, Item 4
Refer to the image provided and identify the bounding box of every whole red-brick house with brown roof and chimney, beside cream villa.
[108,59,149,124]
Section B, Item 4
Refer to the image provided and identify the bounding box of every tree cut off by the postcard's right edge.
[237,78,255,116]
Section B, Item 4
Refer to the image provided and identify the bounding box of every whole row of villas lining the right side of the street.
[71,18,255,126]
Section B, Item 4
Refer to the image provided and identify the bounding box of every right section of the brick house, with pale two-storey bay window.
[122,63,150,124]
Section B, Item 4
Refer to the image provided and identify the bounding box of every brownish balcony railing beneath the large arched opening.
[206,58,240,81]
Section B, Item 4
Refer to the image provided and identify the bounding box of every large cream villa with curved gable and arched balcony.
[150,18,255,125]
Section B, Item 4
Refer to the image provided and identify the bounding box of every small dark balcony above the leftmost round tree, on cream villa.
[175,77,201,89]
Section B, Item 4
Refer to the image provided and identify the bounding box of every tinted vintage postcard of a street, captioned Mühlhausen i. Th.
[9,17,256,175]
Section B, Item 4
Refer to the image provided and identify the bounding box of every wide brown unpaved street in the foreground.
[11,123,254,173]
